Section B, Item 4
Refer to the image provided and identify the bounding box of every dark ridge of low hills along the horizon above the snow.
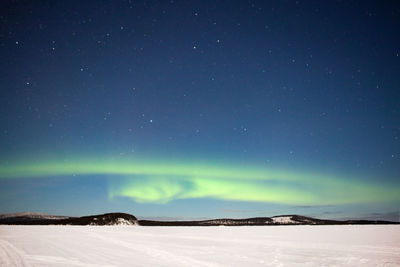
[0,213,399,226]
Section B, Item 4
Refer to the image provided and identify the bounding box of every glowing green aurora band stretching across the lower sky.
[0,160,400,205]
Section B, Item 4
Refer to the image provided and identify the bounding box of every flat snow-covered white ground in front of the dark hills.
[0,225,400,266]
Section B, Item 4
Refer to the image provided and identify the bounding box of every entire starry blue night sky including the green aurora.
[0,0,400,220]
